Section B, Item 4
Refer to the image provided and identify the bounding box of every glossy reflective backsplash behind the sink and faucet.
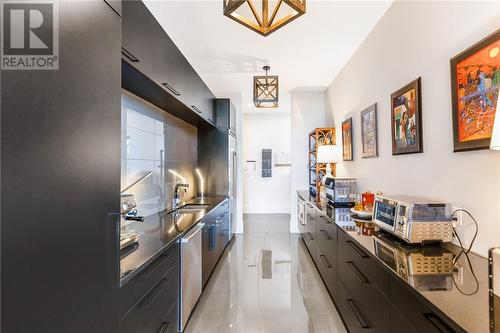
[121,91,197,216]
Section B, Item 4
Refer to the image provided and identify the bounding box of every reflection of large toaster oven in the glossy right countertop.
[373,235,453,291]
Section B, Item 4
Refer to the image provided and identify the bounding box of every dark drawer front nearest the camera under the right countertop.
[391,278,465,333]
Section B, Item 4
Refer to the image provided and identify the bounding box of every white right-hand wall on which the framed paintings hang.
[326,1,500,255]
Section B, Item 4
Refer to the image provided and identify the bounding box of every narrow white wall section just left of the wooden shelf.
[290,90,325,233]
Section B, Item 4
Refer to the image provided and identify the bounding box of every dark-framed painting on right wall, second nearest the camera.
[391,78,424,155]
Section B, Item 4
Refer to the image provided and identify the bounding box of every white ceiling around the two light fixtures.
[145,0,392,105]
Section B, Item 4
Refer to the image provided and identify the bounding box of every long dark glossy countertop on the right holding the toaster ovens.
[297,191,489,333]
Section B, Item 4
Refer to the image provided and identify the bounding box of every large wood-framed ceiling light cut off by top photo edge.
[224,0,306,36]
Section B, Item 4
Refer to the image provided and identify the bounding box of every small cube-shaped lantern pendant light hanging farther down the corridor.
[253,66,279,108]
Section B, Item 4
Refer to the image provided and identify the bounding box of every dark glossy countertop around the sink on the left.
[120,196,226,286]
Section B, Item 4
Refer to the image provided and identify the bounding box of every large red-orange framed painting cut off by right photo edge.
[450,29,500,152]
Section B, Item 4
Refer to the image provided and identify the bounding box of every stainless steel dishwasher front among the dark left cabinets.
[179,223,205,332]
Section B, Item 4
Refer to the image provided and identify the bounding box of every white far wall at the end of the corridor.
[242,112,291,213]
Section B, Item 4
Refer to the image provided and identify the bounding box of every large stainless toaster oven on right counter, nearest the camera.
[373,195,453,244]
